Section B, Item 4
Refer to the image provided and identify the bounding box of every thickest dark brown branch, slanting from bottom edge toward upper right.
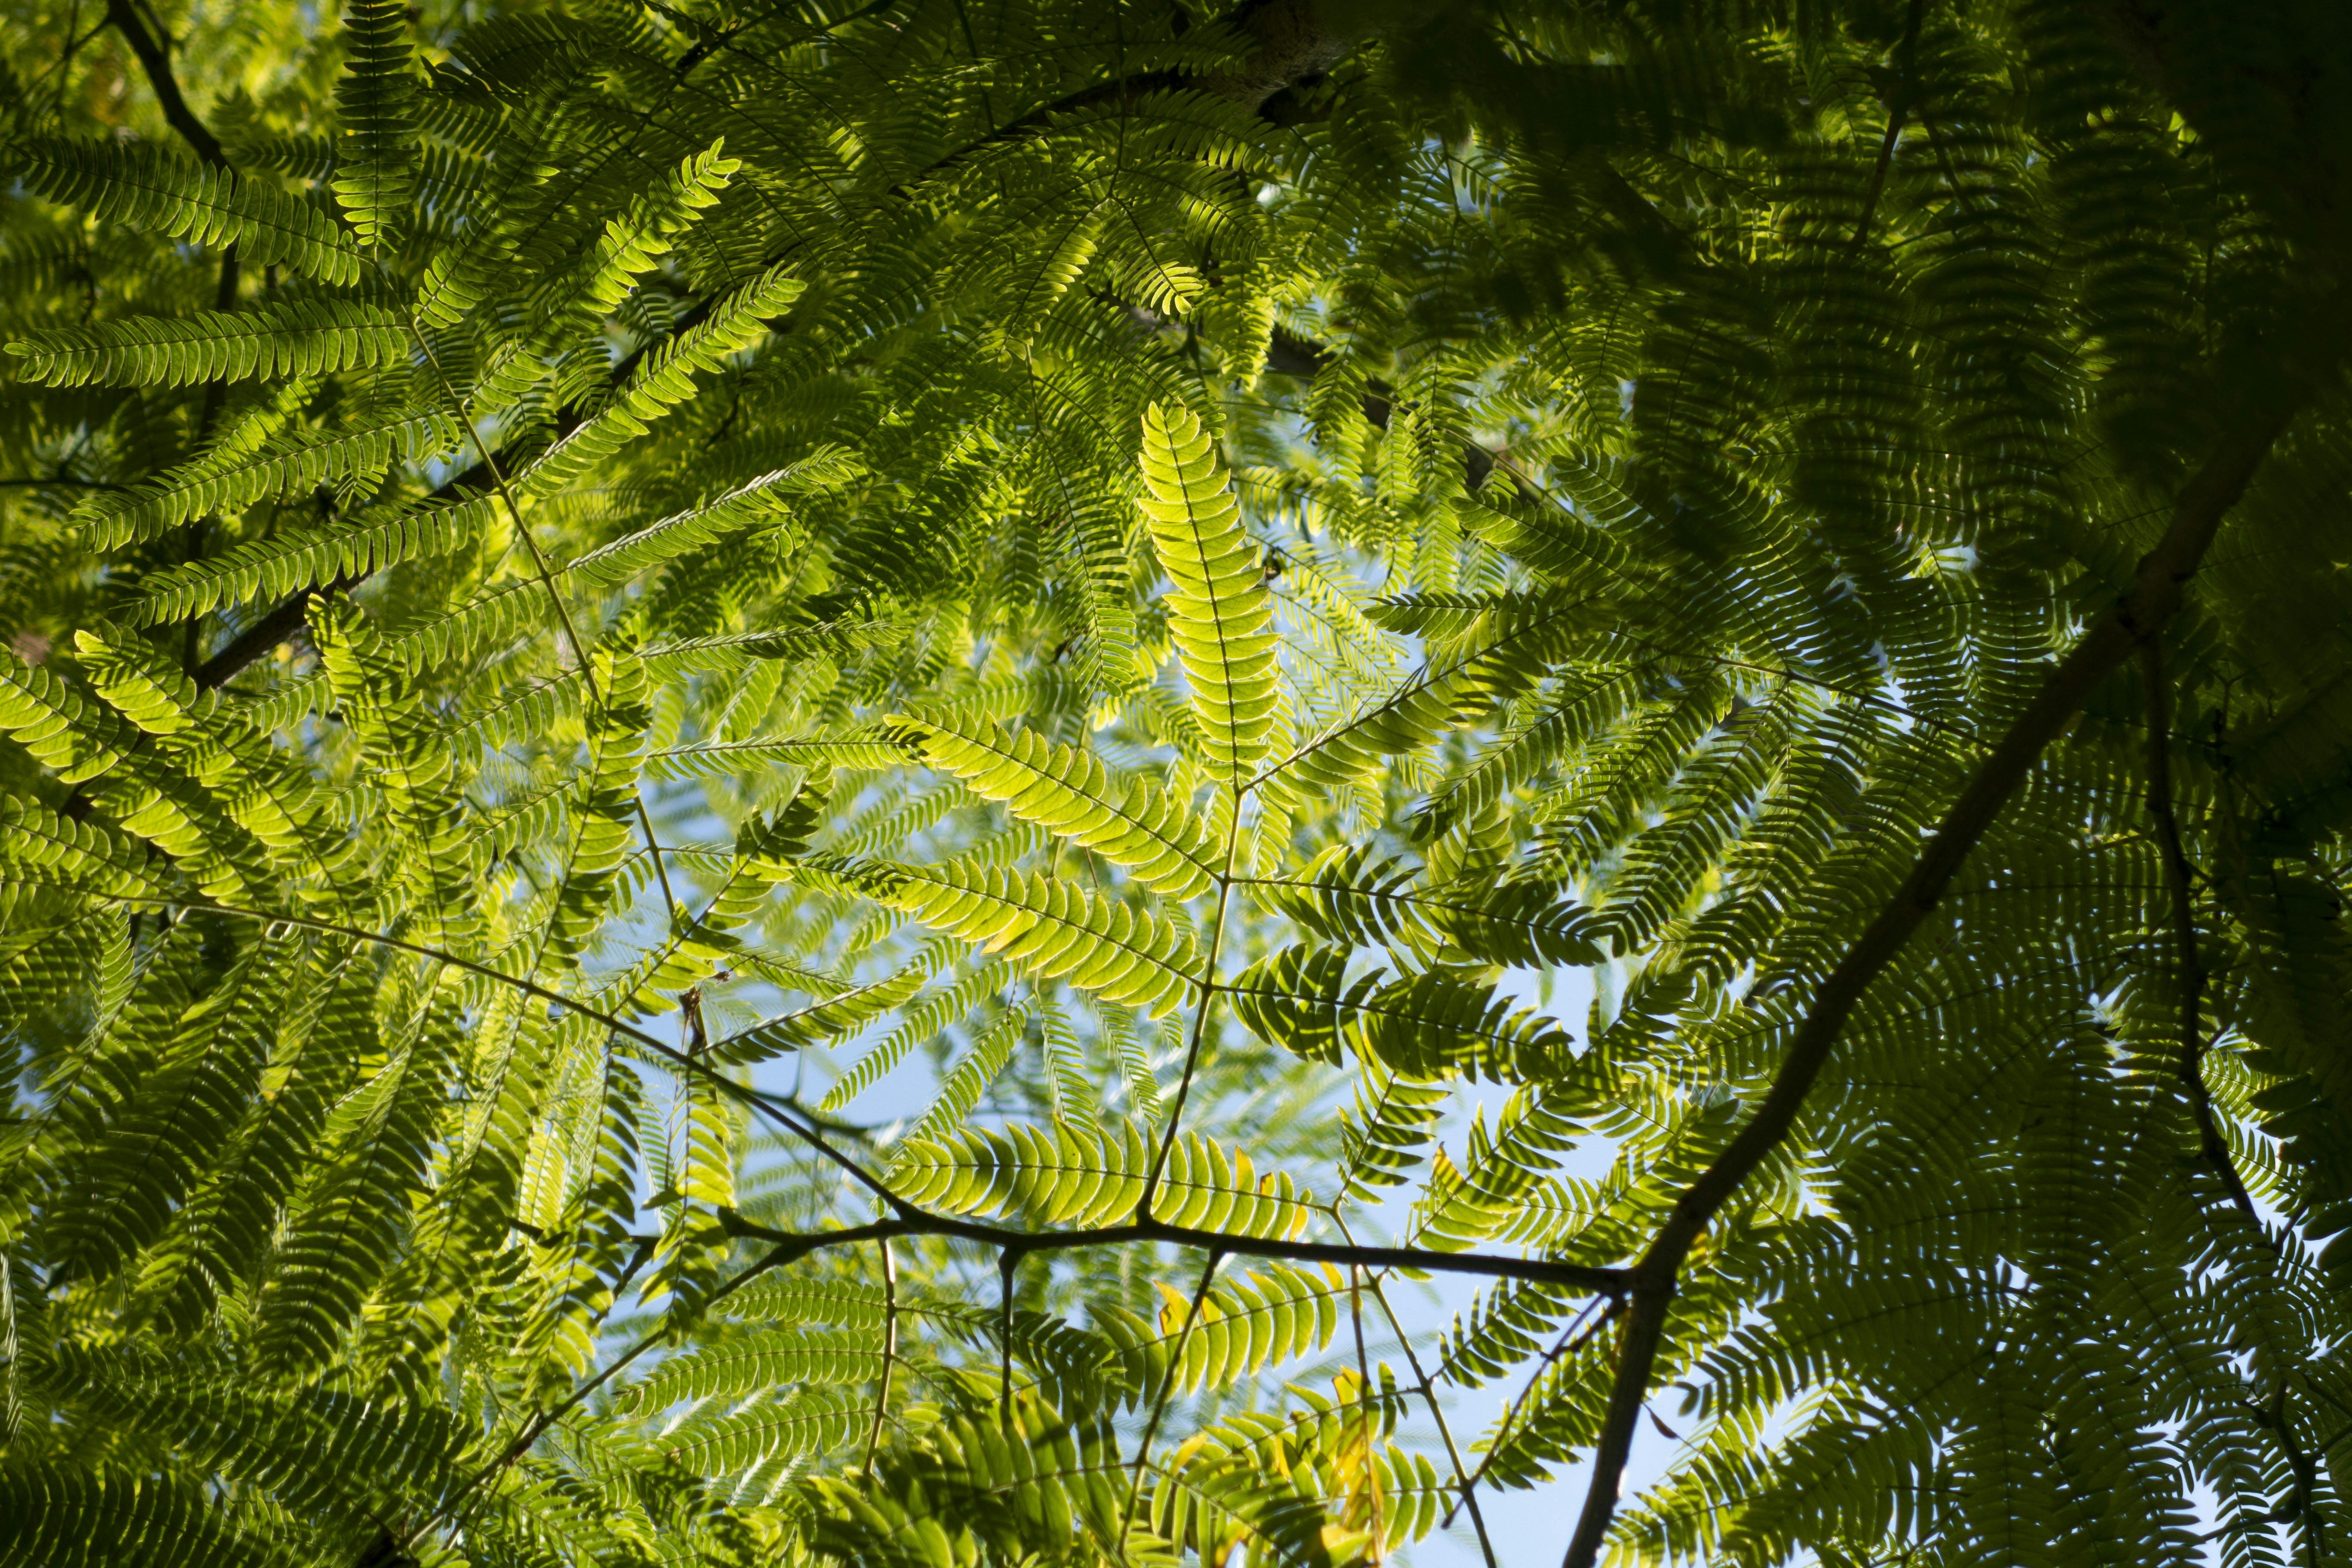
[1564,383,2293,1568]
